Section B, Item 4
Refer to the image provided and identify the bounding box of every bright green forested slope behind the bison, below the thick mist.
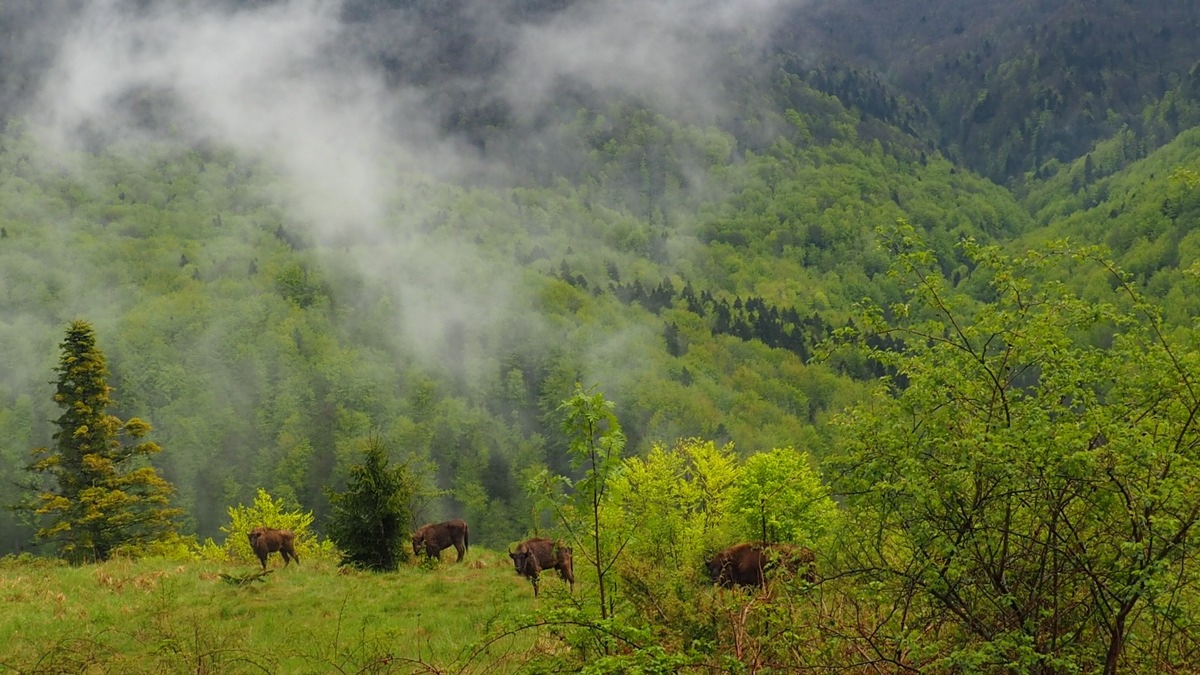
[0,89,1030,545]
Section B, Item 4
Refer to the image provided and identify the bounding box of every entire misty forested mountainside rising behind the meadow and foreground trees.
[0,0,1196,551]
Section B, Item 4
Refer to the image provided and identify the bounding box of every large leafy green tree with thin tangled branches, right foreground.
[829,222,1200,673]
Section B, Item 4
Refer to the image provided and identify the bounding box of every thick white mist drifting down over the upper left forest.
[14,0,801,372]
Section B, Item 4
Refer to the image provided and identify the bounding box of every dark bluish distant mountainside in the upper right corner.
[776,0,1200,184]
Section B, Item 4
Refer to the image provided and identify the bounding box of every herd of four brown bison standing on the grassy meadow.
[250,520,816,597]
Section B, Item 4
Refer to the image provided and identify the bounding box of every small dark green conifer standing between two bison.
[329,436,418,572]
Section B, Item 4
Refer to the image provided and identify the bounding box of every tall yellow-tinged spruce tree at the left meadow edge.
[24,321,181,562]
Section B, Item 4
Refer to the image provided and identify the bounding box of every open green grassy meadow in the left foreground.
[0,549,565,674]
